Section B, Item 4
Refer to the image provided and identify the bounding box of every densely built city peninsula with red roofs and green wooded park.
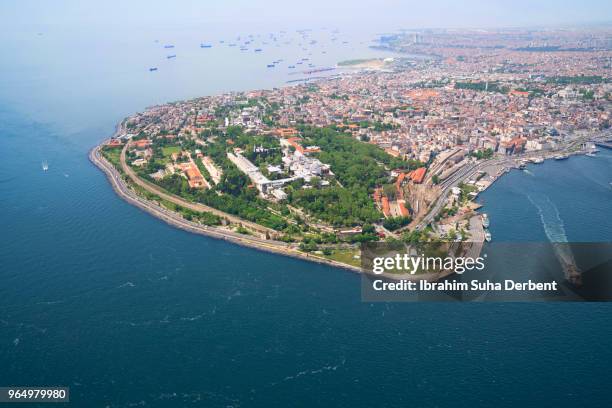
[97,29,612,272]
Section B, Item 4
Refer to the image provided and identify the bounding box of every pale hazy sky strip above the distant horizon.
[0,0,612,31]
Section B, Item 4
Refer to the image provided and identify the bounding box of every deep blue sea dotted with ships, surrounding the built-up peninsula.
[0,26,612,407]
